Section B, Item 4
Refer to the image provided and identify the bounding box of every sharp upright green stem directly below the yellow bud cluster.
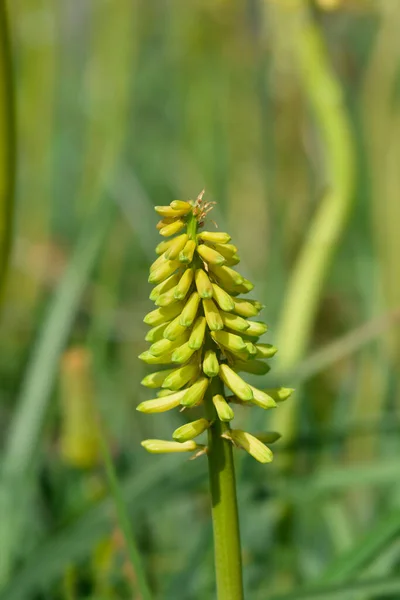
[205,378,244,600]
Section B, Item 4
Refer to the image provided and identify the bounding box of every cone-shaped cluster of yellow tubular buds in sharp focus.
[137,193,293,463]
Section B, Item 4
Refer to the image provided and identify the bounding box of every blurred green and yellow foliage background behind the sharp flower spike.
[0,0,400,600]
